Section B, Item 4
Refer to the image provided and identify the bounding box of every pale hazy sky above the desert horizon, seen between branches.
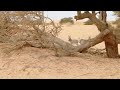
[45,11,116,21]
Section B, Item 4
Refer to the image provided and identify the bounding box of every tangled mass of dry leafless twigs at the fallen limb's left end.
[0,11,62,54]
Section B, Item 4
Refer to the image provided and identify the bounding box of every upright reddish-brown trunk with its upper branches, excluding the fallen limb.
[75,11,118,58]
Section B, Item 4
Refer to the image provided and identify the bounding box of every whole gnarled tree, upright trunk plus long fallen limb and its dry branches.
[0,11,118,58]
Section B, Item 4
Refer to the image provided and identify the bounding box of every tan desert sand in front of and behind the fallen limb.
[0,24,120,79]
